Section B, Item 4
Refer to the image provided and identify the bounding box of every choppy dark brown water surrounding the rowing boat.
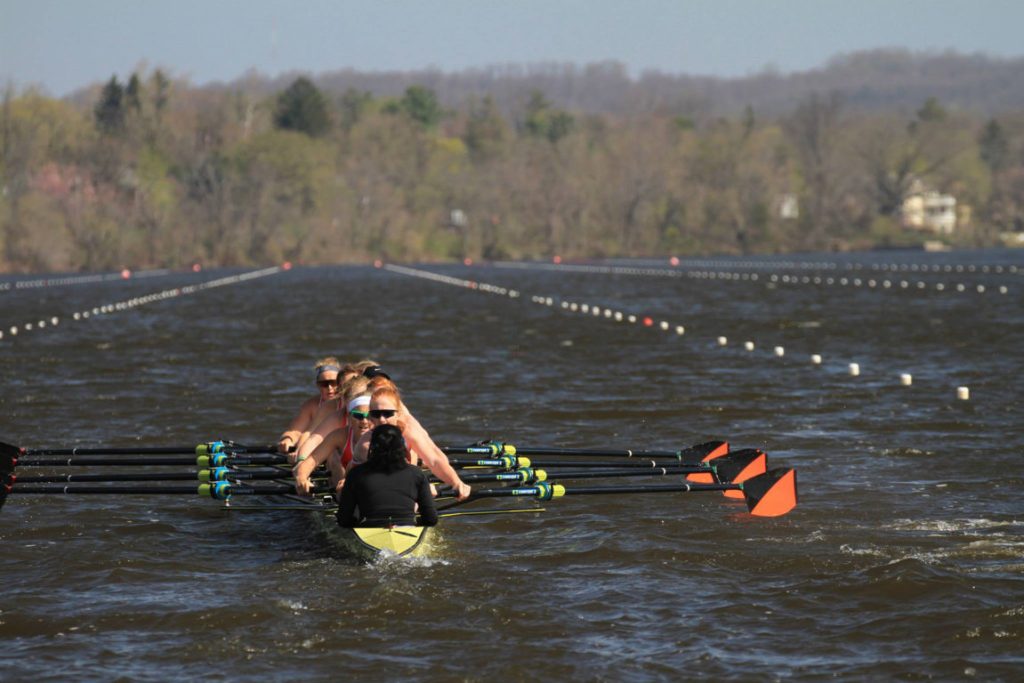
[0,252,1024,681]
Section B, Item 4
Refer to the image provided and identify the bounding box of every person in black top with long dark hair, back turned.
[337,424,437,528]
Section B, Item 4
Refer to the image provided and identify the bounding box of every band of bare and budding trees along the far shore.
[0,70,1024,271]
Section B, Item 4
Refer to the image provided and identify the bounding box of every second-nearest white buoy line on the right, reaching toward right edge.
[495,262,1010,295]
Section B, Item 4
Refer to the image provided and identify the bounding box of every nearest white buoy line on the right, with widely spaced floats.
[376,262,970,400]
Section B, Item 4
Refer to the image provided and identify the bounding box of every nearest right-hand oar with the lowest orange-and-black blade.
[449,468,797,517]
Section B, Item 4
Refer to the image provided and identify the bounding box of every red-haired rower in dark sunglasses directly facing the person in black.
[352,385,472,501]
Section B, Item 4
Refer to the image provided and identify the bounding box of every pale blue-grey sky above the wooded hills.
[0,0,1024,96]
